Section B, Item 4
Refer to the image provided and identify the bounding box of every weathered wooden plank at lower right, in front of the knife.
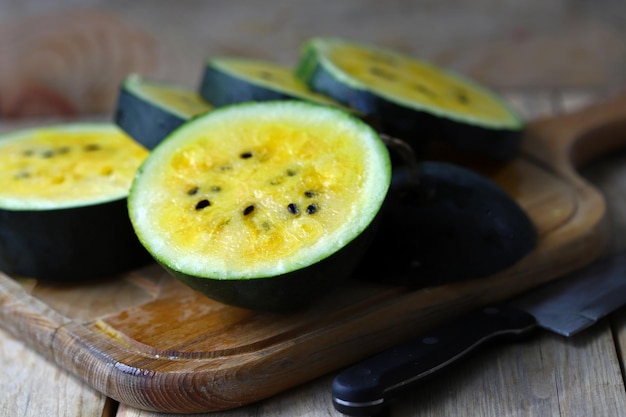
[391,325,626,417]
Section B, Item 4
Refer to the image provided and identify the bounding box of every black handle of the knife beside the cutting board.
[332,306,537,416]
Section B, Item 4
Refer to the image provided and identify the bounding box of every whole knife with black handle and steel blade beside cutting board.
[332,252,626,416]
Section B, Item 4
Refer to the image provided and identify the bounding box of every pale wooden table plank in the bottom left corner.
[0,330,111,417]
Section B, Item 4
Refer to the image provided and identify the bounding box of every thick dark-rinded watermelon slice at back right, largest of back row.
[296,37,524,159]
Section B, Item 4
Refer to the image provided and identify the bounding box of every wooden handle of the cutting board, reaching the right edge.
[524,91,626,174]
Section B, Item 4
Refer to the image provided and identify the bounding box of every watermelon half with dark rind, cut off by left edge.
[0,123,150,281]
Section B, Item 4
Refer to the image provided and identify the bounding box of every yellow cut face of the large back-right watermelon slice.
[325,42,519,126]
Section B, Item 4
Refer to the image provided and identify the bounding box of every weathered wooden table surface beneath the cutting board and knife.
[0,91,626,417]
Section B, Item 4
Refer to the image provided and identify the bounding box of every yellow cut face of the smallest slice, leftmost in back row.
[131,82,212,119]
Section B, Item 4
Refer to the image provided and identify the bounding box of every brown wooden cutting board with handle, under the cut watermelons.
[0,91,626,413]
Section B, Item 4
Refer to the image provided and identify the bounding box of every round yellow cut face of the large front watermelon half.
[131,101,386,278]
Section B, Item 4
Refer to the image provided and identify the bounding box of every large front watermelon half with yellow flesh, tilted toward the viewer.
[129,101,391,310]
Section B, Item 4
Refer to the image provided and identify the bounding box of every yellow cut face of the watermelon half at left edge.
[0,125,148,209]
